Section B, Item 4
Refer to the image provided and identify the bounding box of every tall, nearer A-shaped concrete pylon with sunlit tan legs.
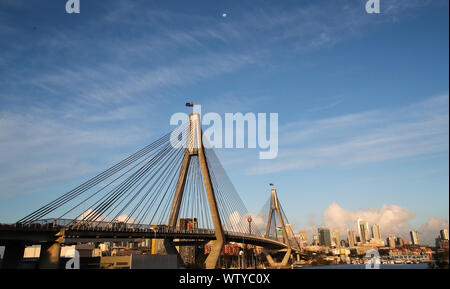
[167,113,225,269]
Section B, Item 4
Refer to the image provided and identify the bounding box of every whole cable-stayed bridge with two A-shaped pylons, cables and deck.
[0,113,299,269]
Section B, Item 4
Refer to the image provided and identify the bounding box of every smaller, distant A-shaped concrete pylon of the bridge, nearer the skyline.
[265,189,292,267]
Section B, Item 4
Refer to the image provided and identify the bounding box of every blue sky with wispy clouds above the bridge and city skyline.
[0,0,449,243]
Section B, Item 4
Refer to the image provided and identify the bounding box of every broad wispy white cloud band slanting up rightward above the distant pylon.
[248,95,449,174]
